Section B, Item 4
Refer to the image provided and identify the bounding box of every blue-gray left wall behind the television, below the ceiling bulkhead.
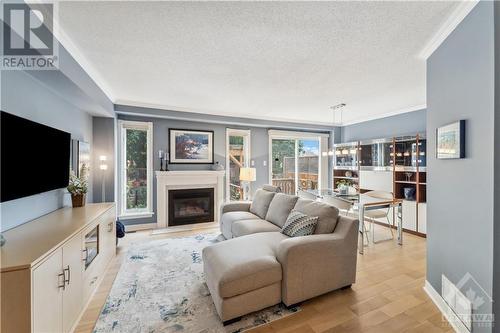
[0,71,92,230]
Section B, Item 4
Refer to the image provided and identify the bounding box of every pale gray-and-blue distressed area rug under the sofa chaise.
[94,234,300,333]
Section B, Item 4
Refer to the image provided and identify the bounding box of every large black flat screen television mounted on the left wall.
[0,111,71,202]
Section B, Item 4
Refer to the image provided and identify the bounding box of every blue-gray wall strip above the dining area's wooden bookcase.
[341,109,426,142]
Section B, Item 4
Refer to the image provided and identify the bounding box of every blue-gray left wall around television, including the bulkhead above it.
[0,41,114,231]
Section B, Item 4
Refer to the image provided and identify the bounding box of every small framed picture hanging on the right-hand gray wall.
[436,120,465,159]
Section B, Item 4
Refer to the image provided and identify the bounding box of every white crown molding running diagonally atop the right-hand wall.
[418,0,479,60]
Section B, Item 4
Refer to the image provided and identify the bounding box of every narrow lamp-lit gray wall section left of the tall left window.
[92,117,116,202]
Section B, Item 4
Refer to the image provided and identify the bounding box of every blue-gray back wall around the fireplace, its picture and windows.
[118,115,332,225]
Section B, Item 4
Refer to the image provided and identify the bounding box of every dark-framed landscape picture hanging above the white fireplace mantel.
[168,129,214,164]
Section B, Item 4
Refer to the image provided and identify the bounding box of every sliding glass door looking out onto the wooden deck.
[270,133,322,194]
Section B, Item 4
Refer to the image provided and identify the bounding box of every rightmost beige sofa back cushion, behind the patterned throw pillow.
[294,199,339,234]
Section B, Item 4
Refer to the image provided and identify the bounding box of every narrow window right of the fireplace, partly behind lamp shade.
[226,128,250,201]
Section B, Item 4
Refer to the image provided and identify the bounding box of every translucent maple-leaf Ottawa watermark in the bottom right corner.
[443,273,495,330]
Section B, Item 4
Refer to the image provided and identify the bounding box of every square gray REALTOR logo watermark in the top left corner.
[0,1,59,70]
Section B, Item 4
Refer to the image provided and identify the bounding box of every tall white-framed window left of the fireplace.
[118,120,153,218]
